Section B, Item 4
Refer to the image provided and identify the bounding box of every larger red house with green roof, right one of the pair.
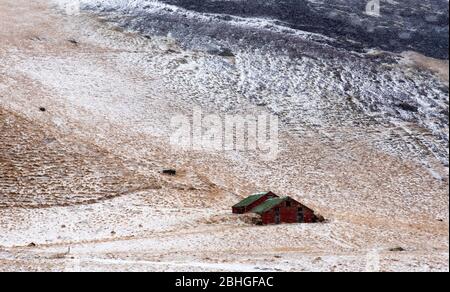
[251,197,320,225]
